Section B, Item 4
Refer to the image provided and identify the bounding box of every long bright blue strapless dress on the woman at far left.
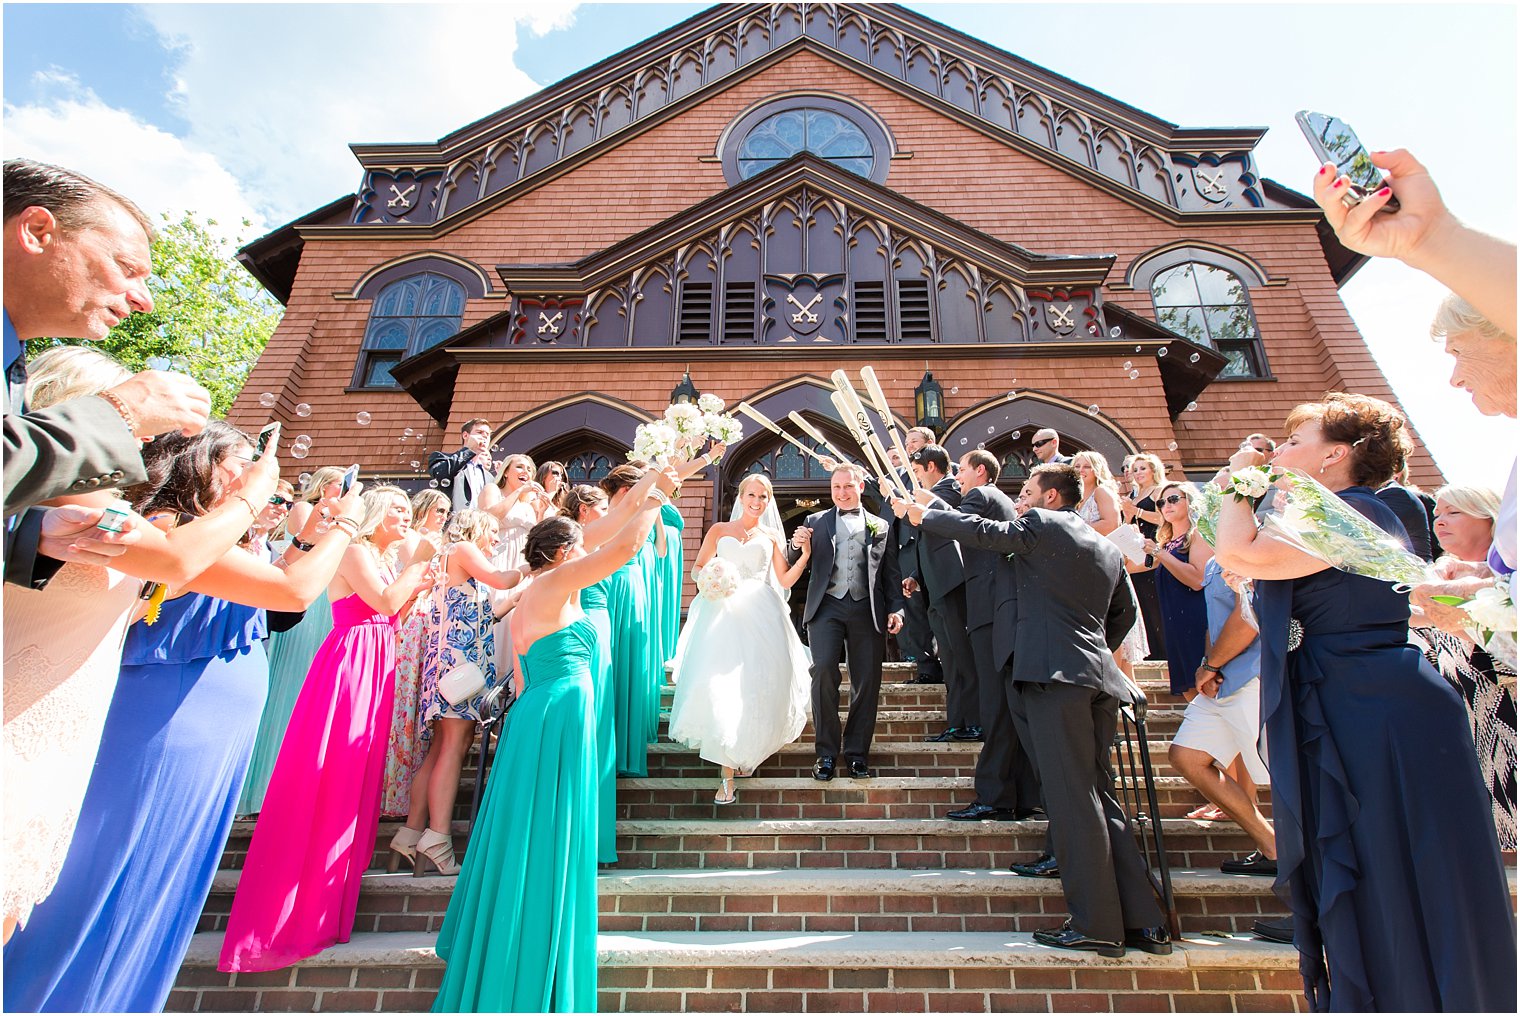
[5,593,269,1013]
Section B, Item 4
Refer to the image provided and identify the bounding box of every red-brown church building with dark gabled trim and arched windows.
[231,3,1439,538]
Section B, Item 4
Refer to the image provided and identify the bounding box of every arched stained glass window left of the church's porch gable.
[354,272,465,388]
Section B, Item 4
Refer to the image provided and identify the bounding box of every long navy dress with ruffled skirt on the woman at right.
[1256,487,1515,1013]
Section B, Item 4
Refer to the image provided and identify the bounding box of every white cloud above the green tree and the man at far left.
[5,71,268,239]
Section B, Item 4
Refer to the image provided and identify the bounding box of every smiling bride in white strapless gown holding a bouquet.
[670,473,812,805]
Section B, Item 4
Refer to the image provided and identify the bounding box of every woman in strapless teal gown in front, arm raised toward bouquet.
[433,470,675,1013]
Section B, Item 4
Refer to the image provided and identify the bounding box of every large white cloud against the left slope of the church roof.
[141,0,578,225]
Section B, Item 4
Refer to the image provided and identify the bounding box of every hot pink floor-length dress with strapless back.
[217,590,397,972]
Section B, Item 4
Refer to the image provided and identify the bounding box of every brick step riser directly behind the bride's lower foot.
[617,767,1271,820]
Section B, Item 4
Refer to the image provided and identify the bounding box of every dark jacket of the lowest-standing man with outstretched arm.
[920,508,1138,700]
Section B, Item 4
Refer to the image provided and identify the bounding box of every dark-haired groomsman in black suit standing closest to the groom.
[903,444,982,741]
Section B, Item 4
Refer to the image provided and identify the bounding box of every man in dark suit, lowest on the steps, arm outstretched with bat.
[907,464,1172,957]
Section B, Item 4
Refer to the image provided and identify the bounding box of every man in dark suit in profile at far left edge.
[0,160,211,586]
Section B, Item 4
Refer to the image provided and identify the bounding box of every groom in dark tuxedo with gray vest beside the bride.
[787,465,903,780]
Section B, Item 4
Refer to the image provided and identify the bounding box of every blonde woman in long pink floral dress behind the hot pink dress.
[380,487,450,815]
